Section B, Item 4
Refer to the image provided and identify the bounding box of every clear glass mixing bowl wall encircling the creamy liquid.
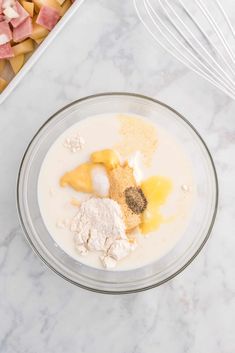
[17,93,218,294]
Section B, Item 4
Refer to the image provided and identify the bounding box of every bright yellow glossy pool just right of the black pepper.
[140,176,172,234]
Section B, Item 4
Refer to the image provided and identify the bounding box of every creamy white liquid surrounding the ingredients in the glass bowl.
[38,114,196,270]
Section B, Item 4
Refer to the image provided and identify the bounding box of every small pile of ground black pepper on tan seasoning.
[124,186,147,214]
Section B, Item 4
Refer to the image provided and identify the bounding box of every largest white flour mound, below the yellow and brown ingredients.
[71,198,136,268]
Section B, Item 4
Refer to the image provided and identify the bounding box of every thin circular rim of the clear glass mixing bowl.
[16,91,219,295]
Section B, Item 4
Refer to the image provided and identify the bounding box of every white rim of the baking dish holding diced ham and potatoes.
[0,0,84,104]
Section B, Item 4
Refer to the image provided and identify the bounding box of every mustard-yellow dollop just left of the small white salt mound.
[60,163,93,192]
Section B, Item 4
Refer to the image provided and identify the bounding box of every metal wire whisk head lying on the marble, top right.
[133,0,235,99]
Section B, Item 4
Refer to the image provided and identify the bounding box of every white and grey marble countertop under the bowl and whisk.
[0,0,235,353]
